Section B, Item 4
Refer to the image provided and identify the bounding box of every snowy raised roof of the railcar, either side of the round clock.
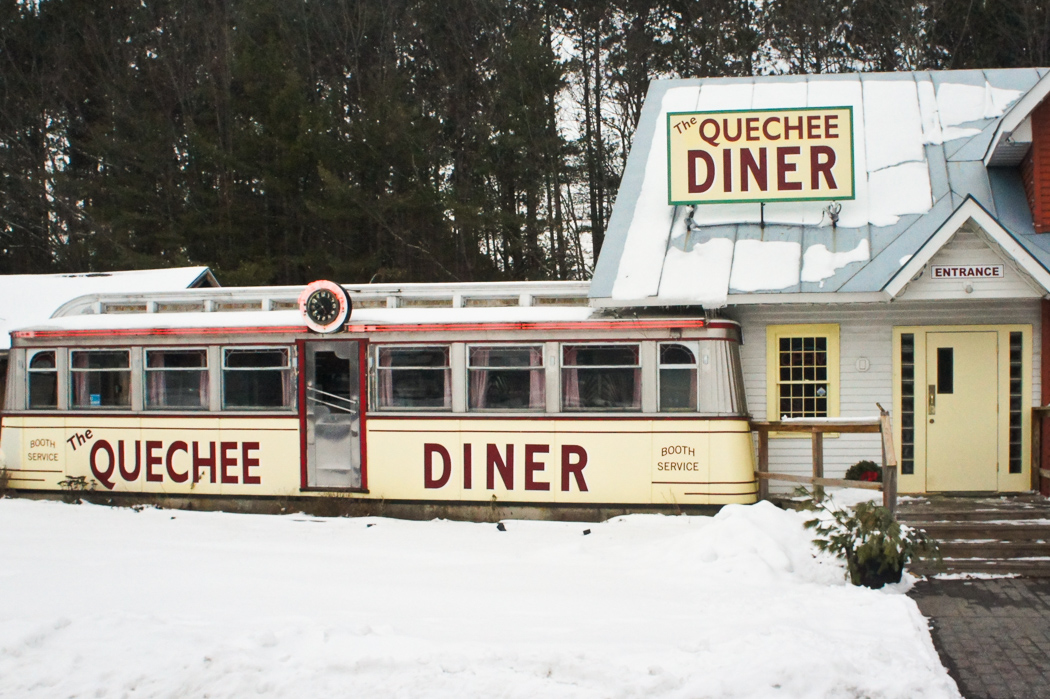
[6,281,613,338]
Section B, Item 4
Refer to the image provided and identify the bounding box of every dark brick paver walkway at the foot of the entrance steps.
[909,578,1050,699]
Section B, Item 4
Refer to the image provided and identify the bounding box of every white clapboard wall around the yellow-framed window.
[727,299,1041,491]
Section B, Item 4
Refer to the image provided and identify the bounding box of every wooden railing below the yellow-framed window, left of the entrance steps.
[751,405,897,512]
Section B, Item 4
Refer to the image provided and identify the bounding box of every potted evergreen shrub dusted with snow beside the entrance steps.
[805,493,940,589]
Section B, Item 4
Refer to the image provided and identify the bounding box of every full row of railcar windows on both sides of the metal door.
[16,341,744,412]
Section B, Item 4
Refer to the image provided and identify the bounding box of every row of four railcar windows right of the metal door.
[373,340,747,415]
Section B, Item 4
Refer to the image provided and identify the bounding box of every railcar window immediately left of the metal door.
[223,347,295,410]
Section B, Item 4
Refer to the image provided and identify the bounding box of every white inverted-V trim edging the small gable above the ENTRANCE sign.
[883,196,1050,298]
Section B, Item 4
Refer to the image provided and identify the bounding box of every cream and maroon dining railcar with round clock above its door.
[0,282,757,516]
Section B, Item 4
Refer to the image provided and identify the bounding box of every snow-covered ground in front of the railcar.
[0,500,959,699]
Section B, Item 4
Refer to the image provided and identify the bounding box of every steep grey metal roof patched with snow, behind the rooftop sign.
[590,68,1050,309]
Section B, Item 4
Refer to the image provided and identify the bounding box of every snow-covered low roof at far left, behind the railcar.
[0,267,215,351]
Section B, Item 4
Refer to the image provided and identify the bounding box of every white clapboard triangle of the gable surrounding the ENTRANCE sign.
[898,227,1041,301]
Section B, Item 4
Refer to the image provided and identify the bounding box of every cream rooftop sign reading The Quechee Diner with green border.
[667,107,856,205]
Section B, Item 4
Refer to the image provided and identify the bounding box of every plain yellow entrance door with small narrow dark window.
[917,332,999,492]
